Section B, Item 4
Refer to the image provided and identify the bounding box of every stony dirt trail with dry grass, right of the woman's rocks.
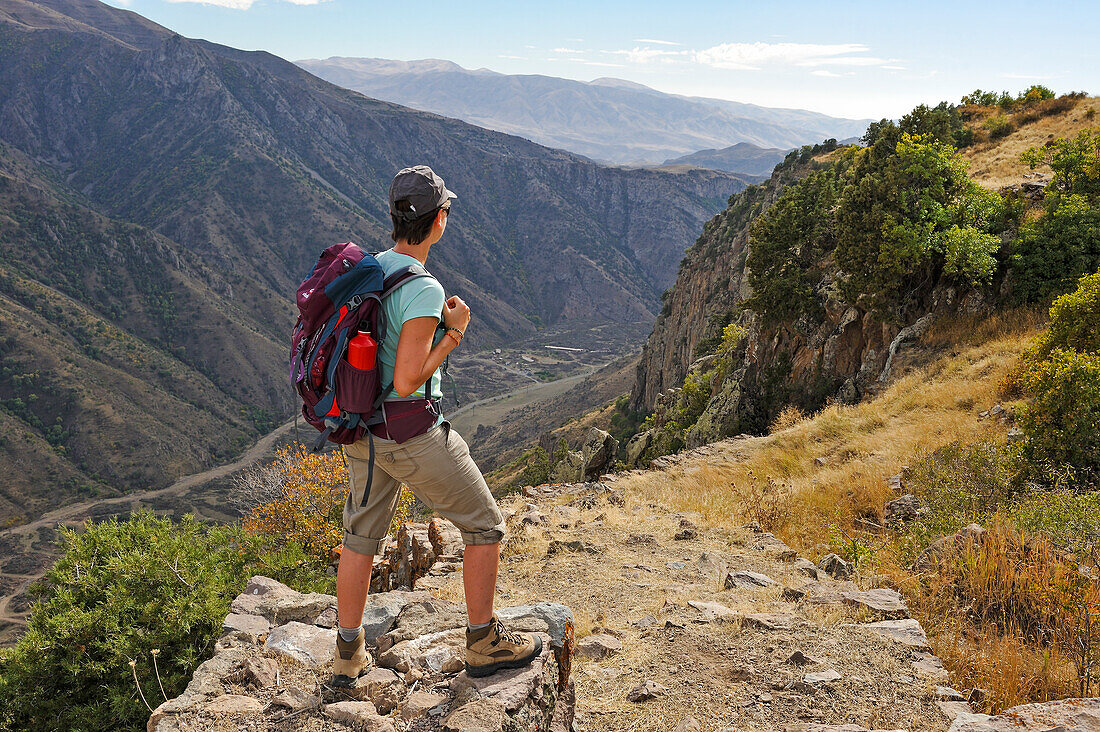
[418,481,949,732]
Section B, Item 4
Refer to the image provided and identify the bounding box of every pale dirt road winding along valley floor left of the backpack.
[0,419,295,638]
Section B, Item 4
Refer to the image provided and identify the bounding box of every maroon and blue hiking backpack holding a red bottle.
[290,242,432,451]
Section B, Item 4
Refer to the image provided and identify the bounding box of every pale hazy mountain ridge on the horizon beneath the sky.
[297,56,872,165]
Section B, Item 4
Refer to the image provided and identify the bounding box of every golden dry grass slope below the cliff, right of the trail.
[626,310,1038,553]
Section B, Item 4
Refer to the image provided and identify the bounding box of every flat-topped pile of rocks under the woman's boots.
[147,572,574,732]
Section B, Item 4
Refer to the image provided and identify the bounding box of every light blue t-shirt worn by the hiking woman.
[375,249,447,398]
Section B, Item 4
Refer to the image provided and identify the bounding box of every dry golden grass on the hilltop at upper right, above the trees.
[961,97,1100,189]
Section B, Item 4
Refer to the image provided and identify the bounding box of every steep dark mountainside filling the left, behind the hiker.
[0,0,745,517]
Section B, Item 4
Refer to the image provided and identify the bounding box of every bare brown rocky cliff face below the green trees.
[628,153,993,451]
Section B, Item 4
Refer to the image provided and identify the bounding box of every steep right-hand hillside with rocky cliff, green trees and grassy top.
[628,95,1096,453]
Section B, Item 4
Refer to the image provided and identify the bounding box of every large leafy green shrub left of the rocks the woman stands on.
[0,511,320,732]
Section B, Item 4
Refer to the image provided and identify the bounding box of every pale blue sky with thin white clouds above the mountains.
[108,0,1100,119]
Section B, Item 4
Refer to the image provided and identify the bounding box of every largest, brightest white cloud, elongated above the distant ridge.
[695,42,887,70]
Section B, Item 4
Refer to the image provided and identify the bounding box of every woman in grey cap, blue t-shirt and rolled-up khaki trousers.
[332,165,542,686]
